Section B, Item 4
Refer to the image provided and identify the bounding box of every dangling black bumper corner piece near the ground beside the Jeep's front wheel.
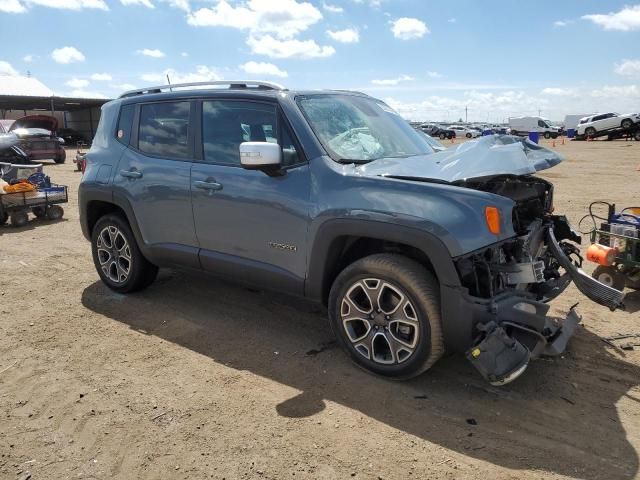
[467,322,530,386]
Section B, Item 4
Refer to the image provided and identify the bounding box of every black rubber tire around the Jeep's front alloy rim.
[329,254,444,379]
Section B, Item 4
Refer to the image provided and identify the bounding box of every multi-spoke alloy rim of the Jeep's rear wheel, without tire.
[96,225,131,283]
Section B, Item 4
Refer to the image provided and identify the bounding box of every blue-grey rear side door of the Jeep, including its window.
[113,100,199,267]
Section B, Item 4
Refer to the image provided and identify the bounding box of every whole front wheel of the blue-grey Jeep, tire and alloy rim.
[329,254,444,379]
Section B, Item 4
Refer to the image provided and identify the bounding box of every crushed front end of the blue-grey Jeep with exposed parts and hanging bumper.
[456,176,624,385]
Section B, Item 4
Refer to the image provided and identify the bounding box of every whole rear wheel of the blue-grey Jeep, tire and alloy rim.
[91,214,158,293]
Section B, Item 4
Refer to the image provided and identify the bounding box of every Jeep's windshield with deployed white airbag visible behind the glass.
[298,95,433,163]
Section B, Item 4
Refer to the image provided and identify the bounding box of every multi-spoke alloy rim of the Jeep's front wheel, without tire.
[340,278,420,365]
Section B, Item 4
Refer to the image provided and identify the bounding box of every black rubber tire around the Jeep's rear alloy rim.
[91,214,158,293]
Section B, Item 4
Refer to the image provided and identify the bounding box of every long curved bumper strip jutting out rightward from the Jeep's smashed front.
[547,228,624,311]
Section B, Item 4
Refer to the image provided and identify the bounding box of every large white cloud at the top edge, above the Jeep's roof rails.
[187,0,322,39]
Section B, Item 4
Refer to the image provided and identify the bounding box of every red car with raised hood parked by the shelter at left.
[9,115,67,163]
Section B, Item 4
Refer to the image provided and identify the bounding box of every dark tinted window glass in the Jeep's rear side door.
[138,102,191,159]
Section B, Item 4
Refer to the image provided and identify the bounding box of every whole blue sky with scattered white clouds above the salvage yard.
[0,0,640,121]
